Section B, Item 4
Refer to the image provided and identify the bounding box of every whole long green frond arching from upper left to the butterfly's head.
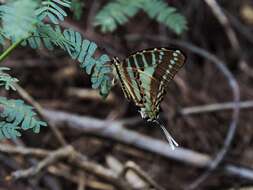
[26,25,112,97]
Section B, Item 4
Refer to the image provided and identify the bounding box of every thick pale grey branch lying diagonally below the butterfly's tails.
[41,110,253,181]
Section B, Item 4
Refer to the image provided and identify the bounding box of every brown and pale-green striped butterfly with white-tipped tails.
[112,48,186,149]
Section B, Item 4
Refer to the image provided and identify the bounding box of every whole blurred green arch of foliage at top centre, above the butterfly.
[94,0,187,34]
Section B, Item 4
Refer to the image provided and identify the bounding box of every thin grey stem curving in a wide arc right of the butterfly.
[128,35,240,189]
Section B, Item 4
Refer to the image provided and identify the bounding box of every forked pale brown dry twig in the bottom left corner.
[0,145,132,190]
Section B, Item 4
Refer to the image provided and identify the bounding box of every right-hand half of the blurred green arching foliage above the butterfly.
[143,0,187,34]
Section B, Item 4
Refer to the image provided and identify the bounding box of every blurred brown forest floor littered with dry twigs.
[0,0,253,190]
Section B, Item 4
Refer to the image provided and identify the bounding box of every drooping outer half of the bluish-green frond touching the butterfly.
[64,29,112,97]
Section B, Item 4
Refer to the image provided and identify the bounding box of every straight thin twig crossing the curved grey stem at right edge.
[178,100,253,115]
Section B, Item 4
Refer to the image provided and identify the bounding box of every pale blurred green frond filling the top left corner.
[0,0,38,41]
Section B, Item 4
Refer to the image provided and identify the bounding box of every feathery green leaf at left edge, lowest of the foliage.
[0,97,47,139]
